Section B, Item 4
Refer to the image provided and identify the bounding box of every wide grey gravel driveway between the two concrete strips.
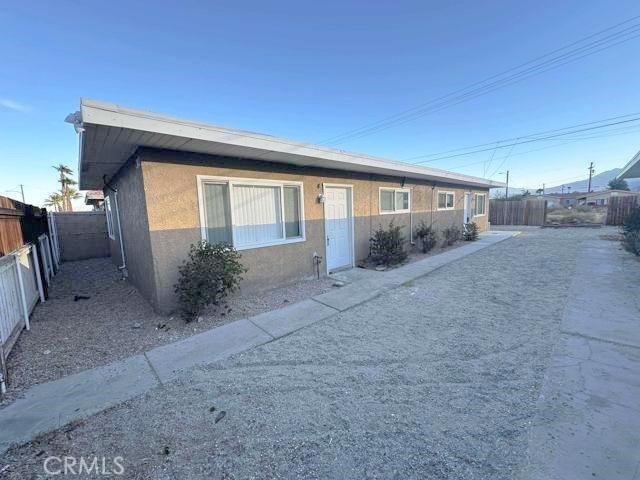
[0,229,613,480]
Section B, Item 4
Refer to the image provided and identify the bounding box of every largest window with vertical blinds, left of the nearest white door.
[200,177,304,250]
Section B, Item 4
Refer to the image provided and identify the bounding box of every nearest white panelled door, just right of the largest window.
[324,187,353,271]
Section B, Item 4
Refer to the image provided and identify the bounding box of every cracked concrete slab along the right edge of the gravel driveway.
[520,240,640,480]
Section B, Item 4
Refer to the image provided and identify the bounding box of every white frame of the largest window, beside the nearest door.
[196,175,306,250]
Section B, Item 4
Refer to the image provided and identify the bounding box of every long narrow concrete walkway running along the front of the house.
[0,232,518,453]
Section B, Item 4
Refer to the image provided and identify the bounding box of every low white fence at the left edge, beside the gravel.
[0,239,51,393]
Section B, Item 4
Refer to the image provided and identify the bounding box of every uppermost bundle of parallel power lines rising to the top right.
[320,16,640,143]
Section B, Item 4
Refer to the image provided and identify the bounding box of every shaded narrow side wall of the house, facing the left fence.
[104,161,157,307]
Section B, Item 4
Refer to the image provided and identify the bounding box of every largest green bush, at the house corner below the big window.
[174,241,247,322]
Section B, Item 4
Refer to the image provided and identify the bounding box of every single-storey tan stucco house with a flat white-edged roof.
[67,100,504,312]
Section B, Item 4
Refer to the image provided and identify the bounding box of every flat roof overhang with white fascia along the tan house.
[67,99,505,190]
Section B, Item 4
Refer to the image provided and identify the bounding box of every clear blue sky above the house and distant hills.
[0,0,640,204]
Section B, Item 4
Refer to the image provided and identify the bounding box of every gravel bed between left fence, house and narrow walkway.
[0,258,333,408]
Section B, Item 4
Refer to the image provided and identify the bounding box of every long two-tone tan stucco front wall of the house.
[134,150,489,312]
